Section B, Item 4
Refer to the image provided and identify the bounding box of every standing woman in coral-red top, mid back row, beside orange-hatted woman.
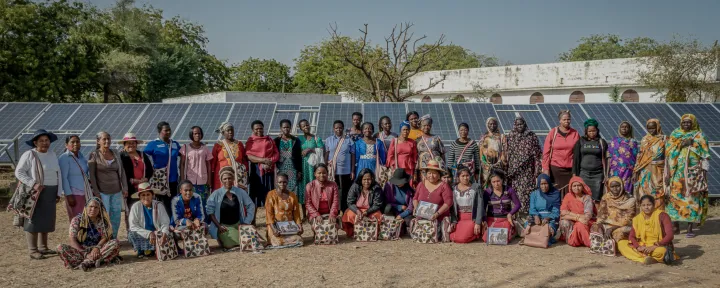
[385,121,418,187]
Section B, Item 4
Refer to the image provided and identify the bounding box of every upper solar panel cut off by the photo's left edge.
[0,103,48,140]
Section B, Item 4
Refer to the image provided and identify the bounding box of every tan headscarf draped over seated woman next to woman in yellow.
[597,176,637,226]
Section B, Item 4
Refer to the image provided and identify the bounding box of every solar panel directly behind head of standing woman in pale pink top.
[173,103,232,143]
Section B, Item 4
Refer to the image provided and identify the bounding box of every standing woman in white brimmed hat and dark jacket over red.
[119,133,153,231]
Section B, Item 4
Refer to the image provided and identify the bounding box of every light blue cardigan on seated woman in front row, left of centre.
[206,186,255,239]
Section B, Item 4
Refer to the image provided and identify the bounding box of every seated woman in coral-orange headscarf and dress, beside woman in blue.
[560,176,595,247]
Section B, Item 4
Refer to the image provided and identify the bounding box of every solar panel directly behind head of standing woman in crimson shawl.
[226,103,276,141]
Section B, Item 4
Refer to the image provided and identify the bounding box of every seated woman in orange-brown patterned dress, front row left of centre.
[265,173,303,248]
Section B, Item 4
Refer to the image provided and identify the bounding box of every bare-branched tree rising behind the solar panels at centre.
[330,23,447,102]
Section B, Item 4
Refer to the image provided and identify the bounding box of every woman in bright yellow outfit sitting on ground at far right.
[618,195,679,264]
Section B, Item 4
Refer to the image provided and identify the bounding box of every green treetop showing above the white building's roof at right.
[558,34,658,62]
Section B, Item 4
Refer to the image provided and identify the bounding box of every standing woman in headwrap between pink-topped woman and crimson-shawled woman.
[211,122,248,191]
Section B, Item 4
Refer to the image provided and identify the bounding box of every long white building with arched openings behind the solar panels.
[400,58,720,104]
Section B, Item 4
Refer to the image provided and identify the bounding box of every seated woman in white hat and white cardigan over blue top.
[128,182,172,259]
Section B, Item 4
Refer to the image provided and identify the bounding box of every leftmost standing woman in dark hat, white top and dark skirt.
[10,129,63,260]
